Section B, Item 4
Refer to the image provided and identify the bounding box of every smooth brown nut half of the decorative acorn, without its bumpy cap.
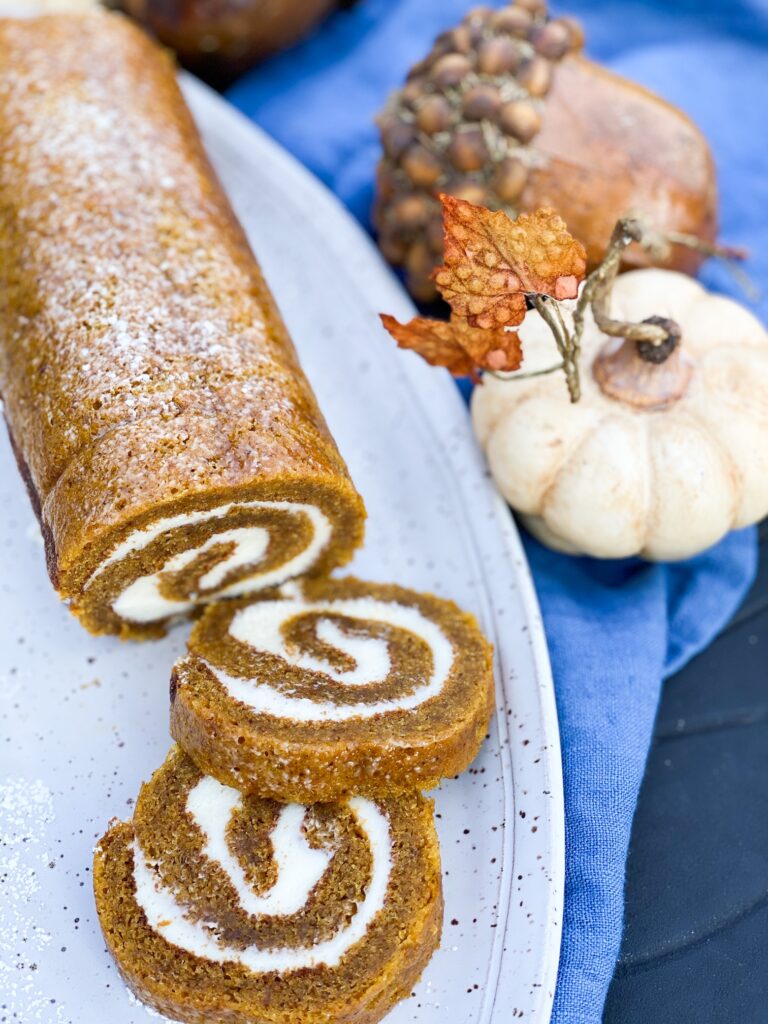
[522,54,717,273]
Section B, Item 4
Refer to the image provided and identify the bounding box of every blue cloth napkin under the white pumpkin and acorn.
[229,0,768,1024]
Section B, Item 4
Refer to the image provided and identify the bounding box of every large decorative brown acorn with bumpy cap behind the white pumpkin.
[374,0,717,300]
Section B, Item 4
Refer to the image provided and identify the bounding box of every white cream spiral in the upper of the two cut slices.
[205,587,455,722]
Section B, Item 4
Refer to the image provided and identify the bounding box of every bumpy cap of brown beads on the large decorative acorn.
[374,0,584,301]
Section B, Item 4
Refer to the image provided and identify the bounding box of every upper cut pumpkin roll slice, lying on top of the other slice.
[171,579,494,801]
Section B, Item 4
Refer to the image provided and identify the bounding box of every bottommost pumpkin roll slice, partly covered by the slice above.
[93,749,442,1024]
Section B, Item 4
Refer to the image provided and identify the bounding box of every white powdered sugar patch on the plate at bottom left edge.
[0,777,69,1024]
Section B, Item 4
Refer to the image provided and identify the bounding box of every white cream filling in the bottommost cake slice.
[133,777,392,974]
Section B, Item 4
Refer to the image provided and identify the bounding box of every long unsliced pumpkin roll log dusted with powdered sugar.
[0,9,365,636]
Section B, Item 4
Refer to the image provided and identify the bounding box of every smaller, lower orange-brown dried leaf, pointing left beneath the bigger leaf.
[381,313,522,377]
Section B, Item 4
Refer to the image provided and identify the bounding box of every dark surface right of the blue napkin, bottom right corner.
[604,523,768,1024]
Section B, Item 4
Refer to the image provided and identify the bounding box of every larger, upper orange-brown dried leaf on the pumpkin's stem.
[434,196,587,329]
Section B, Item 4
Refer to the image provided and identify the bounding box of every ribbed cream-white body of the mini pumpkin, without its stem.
[472,269,768,560]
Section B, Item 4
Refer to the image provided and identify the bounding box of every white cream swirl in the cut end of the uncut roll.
[87,501,332,623]
